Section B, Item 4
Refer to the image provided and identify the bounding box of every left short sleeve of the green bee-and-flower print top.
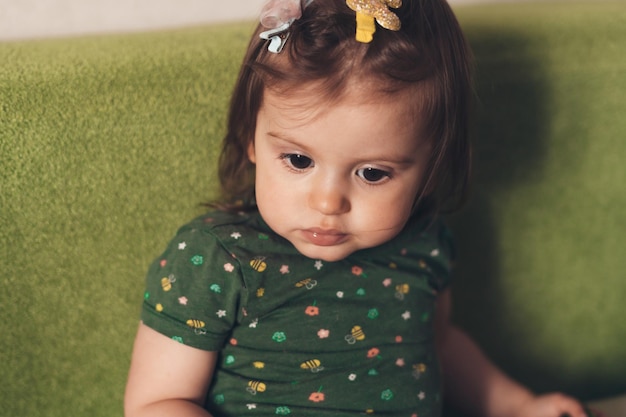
[141,226,244,351]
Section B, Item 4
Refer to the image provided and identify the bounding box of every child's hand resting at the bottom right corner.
[515,393,602,417]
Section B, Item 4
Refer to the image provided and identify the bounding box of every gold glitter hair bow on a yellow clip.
[346,0,402,43]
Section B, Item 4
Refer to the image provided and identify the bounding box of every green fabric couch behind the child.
[0,1,626,417]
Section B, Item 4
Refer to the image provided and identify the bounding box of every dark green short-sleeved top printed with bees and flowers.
[142,212,452,417]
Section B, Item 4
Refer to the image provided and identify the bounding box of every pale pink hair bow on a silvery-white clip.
[259,0,313,54]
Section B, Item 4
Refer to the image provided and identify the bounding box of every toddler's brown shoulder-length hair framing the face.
[214,0,471,214]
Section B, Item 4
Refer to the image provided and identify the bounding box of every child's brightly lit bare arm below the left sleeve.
[124,324,217,417]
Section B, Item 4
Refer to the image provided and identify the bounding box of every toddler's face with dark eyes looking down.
[249,85,430,262]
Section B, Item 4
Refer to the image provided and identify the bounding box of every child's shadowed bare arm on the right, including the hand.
[437,290,585,417]
